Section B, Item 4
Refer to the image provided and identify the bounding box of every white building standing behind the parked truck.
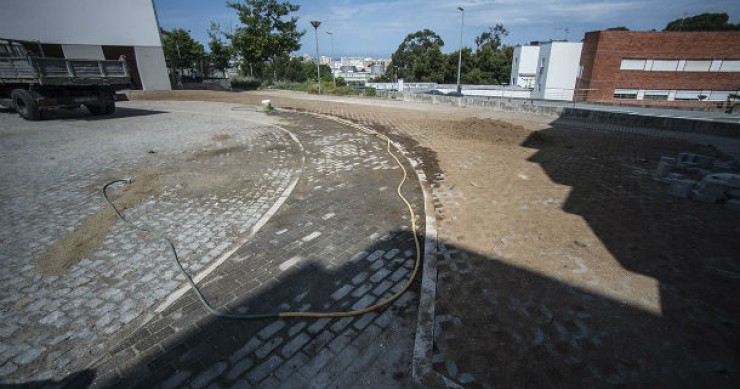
[0,0,170,89]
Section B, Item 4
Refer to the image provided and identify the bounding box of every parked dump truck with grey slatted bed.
[0,38,131,120]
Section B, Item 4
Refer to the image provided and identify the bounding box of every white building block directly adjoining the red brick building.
[532,42,583,101]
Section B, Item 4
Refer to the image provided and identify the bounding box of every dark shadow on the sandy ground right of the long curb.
[435,123,740,387]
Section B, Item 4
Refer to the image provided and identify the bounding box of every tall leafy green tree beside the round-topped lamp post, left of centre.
[226,0,306,79]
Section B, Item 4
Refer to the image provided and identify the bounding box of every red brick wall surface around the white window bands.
[577,31,740,105]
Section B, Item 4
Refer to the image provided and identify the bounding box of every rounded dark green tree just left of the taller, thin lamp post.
[386,29,444,82]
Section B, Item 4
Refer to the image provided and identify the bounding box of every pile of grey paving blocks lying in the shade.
[655,153,740,211]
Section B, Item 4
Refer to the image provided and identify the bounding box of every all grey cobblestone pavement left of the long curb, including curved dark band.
[0,102,423,388]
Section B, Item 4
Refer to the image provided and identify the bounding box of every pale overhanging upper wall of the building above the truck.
[0,0,162,46]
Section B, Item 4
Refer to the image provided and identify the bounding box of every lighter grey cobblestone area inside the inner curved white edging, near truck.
[0,101,300,382]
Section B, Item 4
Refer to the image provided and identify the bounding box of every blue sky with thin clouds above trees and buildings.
[154,0,740,58]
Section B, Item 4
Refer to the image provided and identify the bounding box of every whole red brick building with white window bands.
[576,31,740,107]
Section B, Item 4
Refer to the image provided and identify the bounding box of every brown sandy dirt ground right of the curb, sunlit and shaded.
[131,91,740,387]
